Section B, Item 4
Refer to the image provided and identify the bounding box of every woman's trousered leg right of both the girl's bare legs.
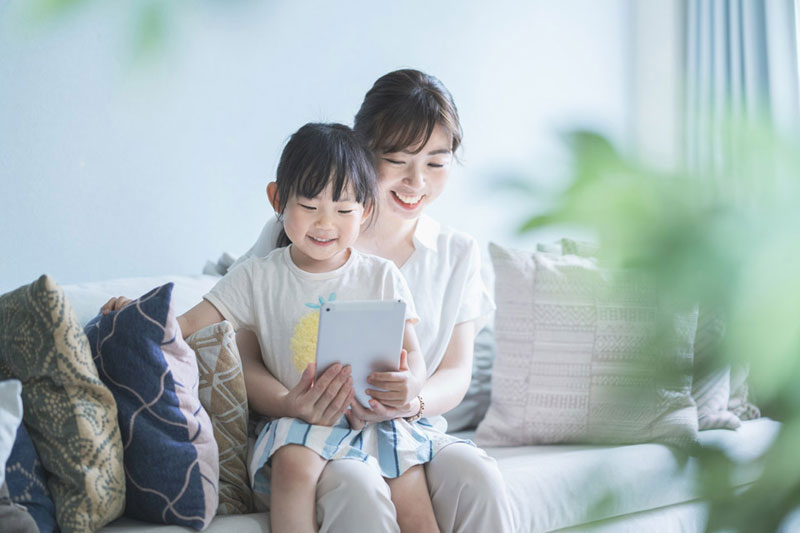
[425,444,514,533]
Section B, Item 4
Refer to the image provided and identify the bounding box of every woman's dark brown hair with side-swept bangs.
[353,69,463,155]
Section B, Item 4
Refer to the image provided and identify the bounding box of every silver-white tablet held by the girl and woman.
[317,300,406,408]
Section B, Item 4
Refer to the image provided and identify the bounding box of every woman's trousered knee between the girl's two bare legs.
[317,459,400,533]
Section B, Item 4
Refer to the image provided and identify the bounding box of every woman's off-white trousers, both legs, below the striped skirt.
[317,444,514,533]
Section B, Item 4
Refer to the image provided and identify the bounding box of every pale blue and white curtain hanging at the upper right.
[684,0,800,176]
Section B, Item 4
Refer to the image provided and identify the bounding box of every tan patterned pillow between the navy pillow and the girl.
[186,321,253,515]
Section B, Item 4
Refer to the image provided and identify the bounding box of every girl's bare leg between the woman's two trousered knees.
[386,465,439,533]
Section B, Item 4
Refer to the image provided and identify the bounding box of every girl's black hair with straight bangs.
[275,122,378,247]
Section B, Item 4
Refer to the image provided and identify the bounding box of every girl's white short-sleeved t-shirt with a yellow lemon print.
[204,246,418,388]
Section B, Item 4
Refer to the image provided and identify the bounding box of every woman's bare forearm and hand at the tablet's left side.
[236,330,353,426]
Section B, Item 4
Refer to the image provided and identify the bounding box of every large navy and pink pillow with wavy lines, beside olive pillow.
[85,283,219,529]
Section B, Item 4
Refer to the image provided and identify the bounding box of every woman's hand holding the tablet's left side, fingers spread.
[283,363,354,426]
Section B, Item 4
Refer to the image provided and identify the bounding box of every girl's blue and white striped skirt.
[248,416,472,494]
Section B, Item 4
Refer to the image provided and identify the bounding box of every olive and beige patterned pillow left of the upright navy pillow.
[0,276,125,531]
